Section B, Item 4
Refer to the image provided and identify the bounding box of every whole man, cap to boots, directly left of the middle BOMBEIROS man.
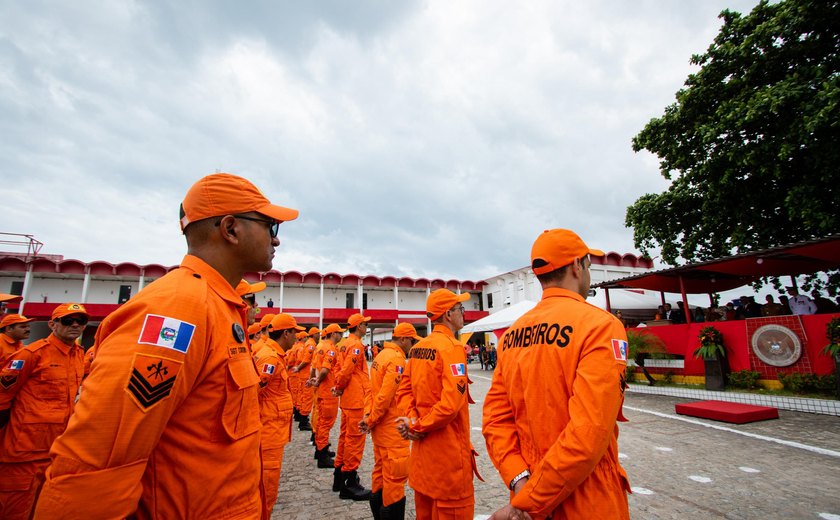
[359,323,421,520]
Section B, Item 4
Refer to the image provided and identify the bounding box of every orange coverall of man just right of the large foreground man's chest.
[256,338,293,516]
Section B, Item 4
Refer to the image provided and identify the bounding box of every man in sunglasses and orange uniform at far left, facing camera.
[0,303,88,519]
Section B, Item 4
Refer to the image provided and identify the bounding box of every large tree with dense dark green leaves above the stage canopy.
[626,0,840,280]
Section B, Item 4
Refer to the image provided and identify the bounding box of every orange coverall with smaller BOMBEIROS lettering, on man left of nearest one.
[397,325,476,519]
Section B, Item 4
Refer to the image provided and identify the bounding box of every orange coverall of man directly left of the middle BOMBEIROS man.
[366,341,409,506]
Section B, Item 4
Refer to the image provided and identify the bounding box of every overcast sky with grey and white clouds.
[0,0,757,280]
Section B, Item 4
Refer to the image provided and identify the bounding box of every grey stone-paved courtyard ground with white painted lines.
[272,365,840,520]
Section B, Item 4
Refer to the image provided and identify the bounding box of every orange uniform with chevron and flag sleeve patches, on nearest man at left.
[35,255,262,520]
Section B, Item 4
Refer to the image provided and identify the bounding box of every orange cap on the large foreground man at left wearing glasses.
[181,173,298,231]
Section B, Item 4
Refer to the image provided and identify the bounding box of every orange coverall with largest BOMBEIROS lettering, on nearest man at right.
[483,288,630,519]
